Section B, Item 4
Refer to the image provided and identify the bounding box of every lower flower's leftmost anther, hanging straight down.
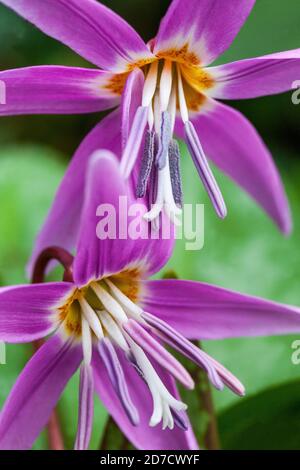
[74,365,94,450]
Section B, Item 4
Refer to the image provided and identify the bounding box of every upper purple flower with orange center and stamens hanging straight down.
[0,0,300,233]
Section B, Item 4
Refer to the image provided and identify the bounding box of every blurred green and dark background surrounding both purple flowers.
[0,0,300,449]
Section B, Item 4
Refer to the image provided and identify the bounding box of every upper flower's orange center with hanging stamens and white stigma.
[121,55,226,228]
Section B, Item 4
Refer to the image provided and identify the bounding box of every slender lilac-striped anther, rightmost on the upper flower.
[184,121,227,219]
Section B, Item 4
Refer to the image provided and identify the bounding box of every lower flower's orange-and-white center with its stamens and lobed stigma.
[59,271,193,428]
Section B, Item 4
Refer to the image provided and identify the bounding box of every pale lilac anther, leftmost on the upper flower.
[120,106,148,178]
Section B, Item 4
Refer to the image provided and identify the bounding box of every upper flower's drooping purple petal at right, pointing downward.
[177,99,291,234]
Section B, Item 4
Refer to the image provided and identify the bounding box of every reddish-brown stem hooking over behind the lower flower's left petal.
[31,247,74,450]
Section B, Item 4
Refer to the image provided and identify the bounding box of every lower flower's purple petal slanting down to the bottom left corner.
[0,335,82,450]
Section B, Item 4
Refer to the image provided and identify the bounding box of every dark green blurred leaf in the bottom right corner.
[219,382,300,450]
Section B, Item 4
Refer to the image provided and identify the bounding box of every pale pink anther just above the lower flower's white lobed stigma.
[123,320,194,389]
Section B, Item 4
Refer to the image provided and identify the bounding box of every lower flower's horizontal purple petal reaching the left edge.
[0,282,72,343]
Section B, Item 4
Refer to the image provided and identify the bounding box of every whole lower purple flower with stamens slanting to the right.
[0,151,300,449]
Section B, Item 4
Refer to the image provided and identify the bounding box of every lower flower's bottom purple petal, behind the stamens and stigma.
[93,346,198,450]
